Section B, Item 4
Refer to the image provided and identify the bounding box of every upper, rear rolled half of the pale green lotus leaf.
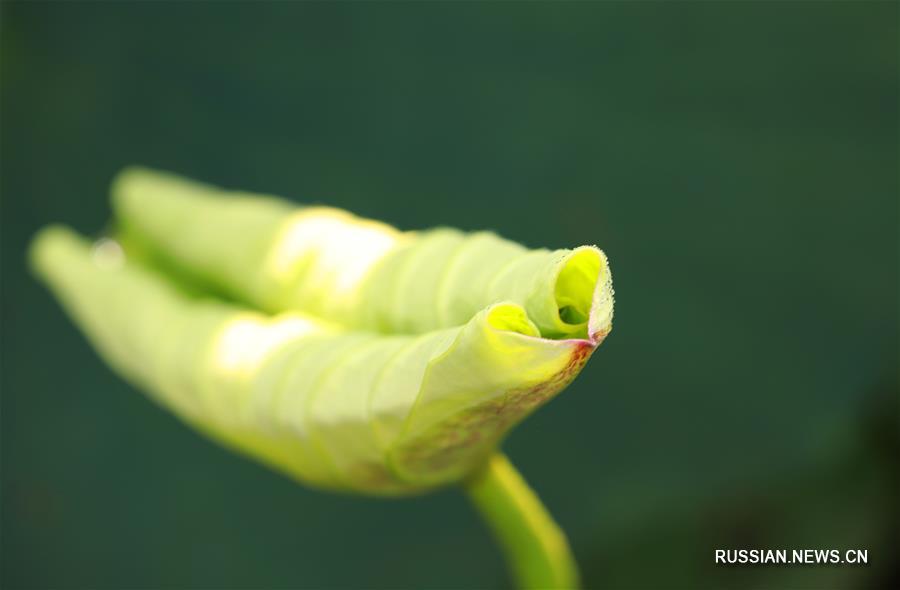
[113,168,613,341]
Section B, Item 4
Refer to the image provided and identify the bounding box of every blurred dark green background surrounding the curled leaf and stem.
[0,2,900,589]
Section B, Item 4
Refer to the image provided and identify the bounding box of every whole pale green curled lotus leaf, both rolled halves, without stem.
[31,169,612,495]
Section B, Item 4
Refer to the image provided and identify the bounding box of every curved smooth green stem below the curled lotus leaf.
[465,452,578,590]
